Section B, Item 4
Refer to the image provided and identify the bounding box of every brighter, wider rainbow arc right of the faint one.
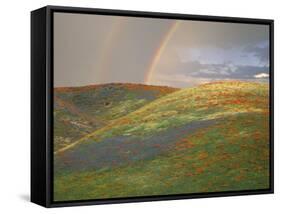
[144,21,181,84]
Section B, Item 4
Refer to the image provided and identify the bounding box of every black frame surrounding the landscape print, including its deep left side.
[31,6,274,207]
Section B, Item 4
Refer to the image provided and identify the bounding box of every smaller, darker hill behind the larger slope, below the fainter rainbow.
[54,83,177,151]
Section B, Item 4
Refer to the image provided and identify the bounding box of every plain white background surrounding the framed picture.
[0,0,276,214]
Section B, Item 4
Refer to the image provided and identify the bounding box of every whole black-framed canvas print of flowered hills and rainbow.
[31,6,273,207]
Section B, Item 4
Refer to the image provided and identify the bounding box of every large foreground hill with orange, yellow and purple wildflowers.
[54,81,269,201]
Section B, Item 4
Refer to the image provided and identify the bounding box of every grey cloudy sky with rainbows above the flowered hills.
[54,12,269,88]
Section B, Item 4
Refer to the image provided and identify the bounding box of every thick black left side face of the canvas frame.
[30,7,47,207]
